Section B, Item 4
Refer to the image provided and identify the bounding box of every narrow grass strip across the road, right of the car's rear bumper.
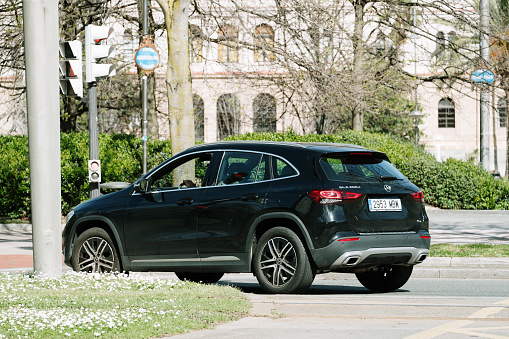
[430,244,509,257]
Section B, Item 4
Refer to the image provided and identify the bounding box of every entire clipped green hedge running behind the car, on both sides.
[0,131,509,219]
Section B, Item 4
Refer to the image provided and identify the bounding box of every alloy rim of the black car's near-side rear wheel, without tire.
[260,237,297,286]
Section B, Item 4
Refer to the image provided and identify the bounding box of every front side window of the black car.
[150,153,212,190]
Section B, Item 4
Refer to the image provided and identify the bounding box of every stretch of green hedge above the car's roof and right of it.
[230,131,509,209]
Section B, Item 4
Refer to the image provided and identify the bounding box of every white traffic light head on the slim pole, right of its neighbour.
[85,25,116,83]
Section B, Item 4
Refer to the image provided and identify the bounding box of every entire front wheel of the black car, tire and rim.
[71,227,121,273]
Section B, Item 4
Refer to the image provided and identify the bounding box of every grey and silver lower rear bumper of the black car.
[311,232,430,271]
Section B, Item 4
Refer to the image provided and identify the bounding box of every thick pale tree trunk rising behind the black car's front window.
[157,0,194,185]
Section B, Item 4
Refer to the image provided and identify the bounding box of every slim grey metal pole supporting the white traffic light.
[88,82,101,199]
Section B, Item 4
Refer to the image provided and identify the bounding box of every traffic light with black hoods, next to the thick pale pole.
[59,40,83,98]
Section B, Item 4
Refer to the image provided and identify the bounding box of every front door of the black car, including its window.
[124,152,218,268]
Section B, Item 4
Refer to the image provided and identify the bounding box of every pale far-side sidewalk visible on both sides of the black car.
[0,224,509,280]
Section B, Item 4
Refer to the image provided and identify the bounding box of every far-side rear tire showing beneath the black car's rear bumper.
[355,266,414,292]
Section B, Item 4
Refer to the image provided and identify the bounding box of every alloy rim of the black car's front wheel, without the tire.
[78,237,115,273]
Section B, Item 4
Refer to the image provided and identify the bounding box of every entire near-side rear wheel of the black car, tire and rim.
[253,227,315,293]
